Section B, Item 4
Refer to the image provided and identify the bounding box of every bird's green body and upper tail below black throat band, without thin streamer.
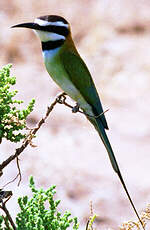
[44,38,120,173]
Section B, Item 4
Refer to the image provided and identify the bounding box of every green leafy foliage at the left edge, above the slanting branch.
[0,64,35,142]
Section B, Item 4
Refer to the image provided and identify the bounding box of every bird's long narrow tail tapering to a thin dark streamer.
[88,117,144,229]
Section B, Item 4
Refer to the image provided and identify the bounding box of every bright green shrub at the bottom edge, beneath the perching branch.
[0,177,78,230]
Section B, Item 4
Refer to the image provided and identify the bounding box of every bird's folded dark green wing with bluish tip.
[60,51,108,129]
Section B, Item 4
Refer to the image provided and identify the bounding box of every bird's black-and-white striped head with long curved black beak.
[12,15,70,42]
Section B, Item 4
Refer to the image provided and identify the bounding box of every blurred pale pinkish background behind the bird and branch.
[0,0,150,229]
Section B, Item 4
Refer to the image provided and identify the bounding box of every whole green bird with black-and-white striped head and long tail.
[12,15,144,229]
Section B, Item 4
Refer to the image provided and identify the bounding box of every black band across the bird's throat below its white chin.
[42,39,65,51]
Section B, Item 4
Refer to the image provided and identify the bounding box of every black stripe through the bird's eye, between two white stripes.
[38,25,69,37]
